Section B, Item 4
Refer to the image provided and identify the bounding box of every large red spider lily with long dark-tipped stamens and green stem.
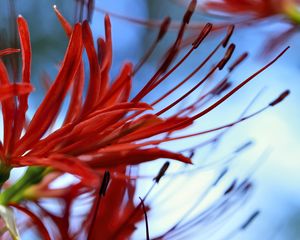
[0,1,289,239]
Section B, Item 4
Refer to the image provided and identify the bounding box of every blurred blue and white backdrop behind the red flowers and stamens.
[0,0,300,240]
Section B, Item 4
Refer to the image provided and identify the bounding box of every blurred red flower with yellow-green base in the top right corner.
[200,0,300,53]
